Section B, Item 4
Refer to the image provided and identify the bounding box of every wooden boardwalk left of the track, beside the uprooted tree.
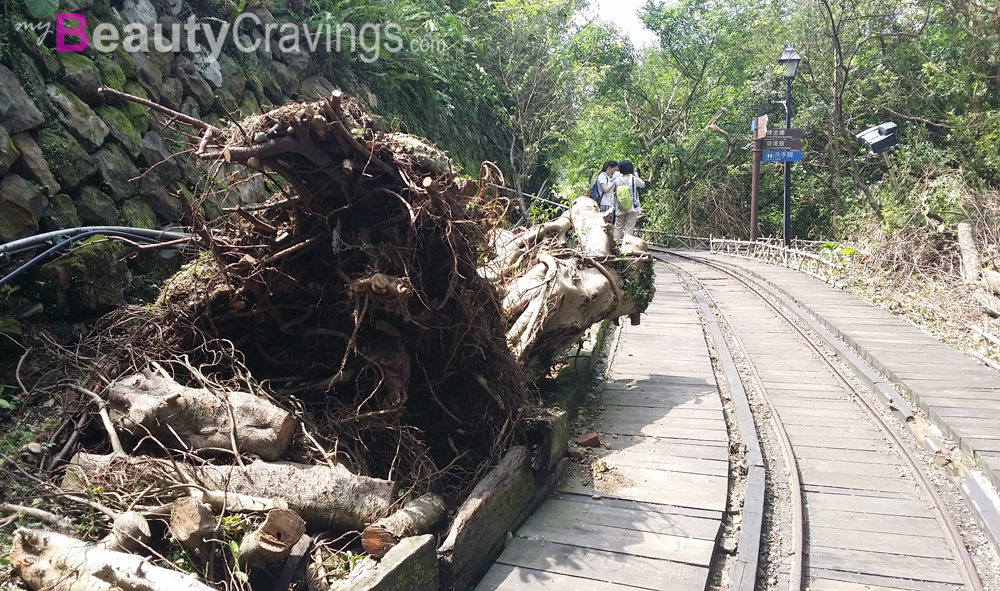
[476,265,729,591]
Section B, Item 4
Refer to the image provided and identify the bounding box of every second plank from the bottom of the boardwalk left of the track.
[492,538,708,591]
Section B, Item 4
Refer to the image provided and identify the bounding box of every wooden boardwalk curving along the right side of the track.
[699,255,1000,487]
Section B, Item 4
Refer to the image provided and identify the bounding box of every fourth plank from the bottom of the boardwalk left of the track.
[521,499,721,540]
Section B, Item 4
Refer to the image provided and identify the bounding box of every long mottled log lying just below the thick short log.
[63,453,396,531]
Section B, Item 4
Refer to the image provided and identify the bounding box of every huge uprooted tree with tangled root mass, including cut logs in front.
[5,89,653,589]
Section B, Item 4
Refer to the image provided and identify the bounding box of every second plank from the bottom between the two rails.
[808,547,962,584]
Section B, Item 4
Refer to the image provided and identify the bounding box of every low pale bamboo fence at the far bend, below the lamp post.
[709,238,844,284]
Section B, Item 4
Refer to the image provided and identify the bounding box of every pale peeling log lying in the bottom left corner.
[10,528,214,591]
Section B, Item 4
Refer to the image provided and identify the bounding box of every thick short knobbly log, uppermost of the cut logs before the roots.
[108,371,297,460]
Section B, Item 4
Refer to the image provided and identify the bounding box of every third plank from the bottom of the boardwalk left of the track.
[516,520,715,567]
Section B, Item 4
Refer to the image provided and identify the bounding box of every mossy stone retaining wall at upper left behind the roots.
[0,0,333,243]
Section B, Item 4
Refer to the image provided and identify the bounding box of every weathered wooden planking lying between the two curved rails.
[678,262,964,591]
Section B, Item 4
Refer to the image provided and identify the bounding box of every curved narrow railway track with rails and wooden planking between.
[651,247,983,591]
